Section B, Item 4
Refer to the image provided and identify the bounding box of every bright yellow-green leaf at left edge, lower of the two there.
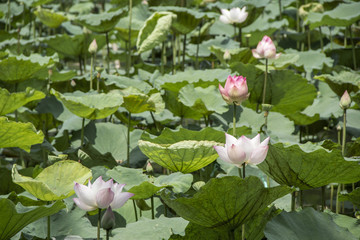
[0,117,44,152]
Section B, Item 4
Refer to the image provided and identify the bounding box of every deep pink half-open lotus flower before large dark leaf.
[219,75,250,105]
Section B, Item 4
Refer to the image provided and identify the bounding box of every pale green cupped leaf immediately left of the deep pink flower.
[179,84,228,116]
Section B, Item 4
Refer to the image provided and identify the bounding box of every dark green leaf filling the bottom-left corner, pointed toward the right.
[0,198,66,239]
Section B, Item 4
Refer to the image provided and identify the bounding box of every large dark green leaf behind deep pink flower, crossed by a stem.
[232,63,316,115]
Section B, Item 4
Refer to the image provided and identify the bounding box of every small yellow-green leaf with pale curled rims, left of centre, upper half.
[121,87,165,113]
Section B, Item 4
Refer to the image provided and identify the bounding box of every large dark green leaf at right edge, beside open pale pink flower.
[258,143,360,190]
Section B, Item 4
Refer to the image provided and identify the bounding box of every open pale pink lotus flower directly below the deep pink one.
[214,133,270,168]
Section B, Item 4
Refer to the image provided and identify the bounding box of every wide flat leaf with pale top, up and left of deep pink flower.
[155,69,231,93]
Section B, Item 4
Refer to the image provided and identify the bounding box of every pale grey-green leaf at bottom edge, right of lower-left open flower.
[112,216,188,240]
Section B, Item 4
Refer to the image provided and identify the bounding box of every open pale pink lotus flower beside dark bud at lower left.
[74,176,134,211]
